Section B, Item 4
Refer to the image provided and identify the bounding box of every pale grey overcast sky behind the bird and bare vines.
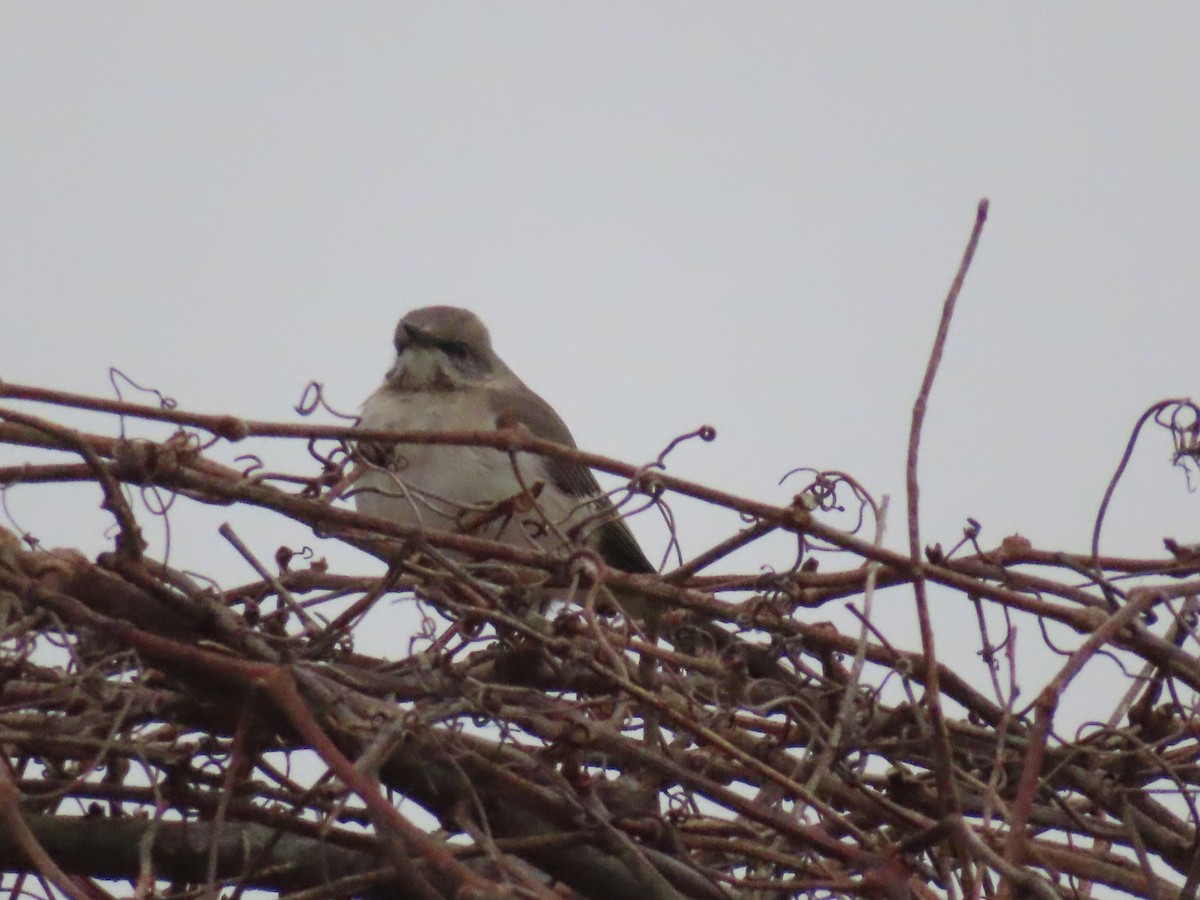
[0,0,1200,720]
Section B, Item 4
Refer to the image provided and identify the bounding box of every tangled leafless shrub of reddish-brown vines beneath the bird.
[0,204,1200,900]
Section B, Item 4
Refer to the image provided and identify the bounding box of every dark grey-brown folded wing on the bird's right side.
[491,385,654,574]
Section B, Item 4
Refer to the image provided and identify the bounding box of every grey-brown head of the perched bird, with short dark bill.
[388,306,508,390]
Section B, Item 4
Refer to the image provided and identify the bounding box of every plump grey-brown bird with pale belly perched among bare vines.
[354,306,655,618]
